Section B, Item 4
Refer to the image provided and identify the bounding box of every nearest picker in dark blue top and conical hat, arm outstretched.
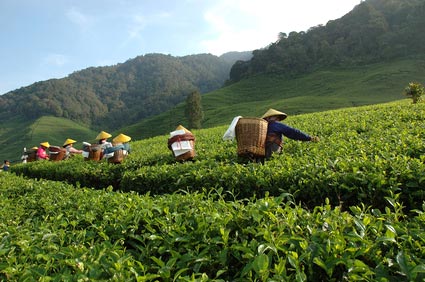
[261,109,320,159]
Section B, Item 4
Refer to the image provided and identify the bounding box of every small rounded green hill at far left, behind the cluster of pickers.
[0,116,97,162]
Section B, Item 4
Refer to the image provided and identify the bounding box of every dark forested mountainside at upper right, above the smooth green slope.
[229,0,425,83]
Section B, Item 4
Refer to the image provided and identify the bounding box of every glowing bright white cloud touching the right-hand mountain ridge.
[201,0,359,55]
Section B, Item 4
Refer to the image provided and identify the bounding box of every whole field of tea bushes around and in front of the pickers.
[0,100,425,281]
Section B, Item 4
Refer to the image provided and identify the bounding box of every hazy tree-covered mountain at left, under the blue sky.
[0,52,251,129]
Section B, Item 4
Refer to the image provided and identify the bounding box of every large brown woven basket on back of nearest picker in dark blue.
[235,118,268,157]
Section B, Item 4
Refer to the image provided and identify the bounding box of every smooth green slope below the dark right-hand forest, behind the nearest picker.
[120,57,425,139]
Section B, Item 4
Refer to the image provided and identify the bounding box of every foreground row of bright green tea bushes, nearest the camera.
[0,173,425,281]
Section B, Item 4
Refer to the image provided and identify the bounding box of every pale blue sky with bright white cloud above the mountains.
[0,0,360,95]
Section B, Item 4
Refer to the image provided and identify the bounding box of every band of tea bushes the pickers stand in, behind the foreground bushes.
[12,101,425,209]
